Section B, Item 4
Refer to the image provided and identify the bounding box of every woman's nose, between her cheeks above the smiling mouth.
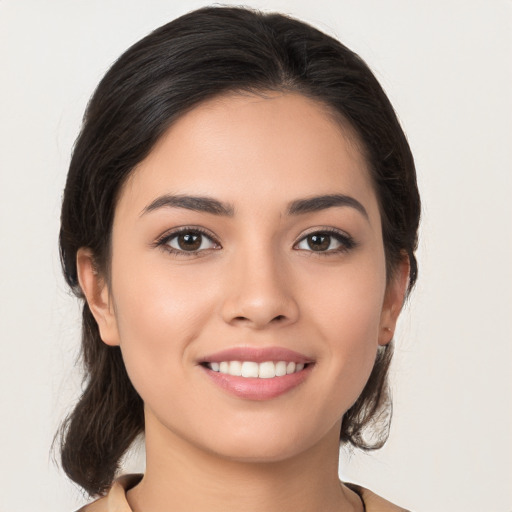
[222,243,299,330]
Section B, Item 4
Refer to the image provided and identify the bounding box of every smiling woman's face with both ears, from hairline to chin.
[78,93,405,461]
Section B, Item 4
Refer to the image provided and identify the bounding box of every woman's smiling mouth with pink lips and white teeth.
[199,347,315,401]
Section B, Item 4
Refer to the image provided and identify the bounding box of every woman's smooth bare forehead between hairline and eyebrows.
[118,92,378,222]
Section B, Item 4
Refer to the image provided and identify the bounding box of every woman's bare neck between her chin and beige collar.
[127,408,362,512]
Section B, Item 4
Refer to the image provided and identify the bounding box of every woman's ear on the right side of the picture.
[379,255,410,345]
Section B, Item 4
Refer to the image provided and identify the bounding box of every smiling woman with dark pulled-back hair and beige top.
[60,8,420,512]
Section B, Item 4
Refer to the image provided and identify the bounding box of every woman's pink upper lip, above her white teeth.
[199,347,313,364]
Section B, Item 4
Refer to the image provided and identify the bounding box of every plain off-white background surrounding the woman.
[0,0,512,512]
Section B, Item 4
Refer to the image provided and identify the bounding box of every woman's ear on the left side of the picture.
[76,247,119,346]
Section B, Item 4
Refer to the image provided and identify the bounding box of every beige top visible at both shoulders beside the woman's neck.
[77,475,407,512]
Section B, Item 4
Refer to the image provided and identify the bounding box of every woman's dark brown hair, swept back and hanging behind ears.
[59,7,420,495]
